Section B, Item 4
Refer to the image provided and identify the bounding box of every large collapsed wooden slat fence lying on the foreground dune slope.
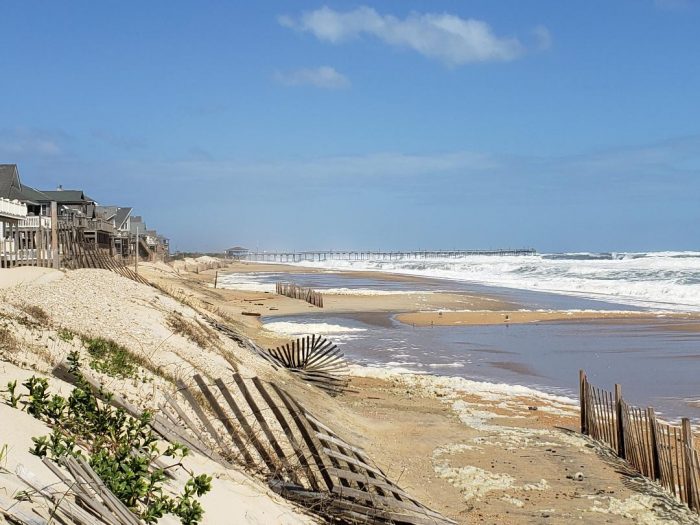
[156,373,454,525]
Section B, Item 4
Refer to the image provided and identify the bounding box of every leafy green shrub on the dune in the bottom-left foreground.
[6,352,212,525]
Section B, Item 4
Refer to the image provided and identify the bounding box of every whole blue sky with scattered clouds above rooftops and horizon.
[0,0,700,252]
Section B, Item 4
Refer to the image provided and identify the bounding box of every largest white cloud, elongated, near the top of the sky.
[278,7,540,66]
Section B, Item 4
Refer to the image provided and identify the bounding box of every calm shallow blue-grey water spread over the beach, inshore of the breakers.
[220,273,700,421]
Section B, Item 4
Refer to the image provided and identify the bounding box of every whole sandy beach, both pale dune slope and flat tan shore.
[0,259,697,524]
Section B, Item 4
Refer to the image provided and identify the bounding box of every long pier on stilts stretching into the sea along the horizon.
[246,248,537,262]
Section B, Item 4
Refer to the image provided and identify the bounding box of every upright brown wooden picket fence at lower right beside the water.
[579,370,700,512]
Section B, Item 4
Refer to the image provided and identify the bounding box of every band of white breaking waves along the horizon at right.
[292,252,700,311]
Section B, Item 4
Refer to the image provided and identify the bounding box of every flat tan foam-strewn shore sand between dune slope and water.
[139,264,697,524]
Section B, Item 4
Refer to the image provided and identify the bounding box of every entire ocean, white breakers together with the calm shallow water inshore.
[220,252,700,421]
